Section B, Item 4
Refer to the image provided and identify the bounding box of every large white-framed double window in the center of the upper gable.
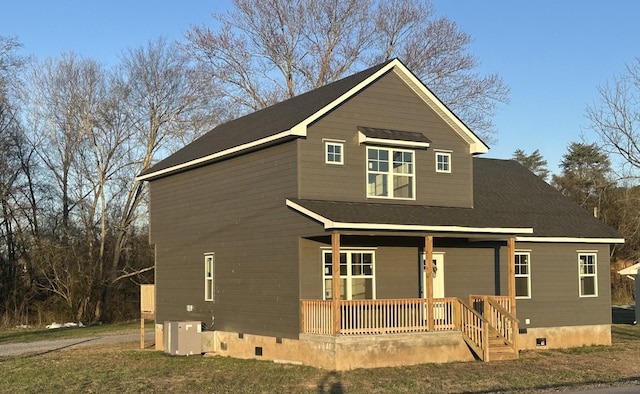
[367,148,415,199]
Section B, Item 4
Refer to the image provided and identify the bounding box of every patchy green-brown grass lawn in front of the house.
[0,325,640,393]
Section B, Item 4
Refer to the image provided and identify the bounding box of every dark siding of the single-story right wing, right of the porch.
[516,243,611,328]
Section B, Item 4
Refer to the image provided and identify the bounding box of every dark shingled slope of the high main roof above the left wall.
[140,60,392,175]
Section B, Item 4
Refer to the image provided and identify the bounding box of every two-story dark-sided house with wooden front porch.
[140,60,623,370]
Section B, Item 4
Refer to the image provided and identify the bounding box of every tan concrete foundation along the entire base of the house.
[156,324,611,371]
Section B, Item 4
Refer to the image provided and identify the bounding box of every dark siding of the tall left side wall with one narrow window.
[150,142,317,338]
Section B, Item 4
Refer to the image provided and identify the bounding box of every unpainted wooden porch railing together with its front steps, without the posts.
[301,295,518,361]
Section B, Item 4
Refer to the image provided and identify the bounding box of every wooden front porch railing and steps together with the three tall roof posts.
[300,231,518,361]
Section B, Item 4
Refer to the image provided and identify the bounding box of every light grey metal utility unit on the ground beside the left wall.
[162,321,202,356]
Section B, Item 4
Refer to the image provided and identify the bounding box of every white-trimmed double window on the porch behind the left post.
[322,250,376,300]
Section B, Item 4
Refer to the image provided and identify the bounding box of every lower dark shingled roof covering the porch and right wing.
[290,158,622,239]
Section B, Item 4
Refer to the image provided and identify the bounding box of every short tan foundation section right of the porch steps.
[518,324,611,350]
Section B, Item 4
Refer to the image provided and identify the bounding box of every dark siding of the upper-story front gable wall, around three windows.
[299,73,473,207]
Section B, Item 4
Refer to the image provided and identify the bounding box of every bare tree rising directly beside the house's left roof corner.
[109,38,219,290]
